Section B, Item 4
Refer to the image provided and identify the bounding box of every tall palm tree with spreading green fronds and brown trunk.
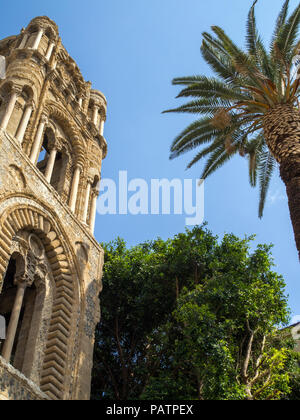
[165,0,300,257]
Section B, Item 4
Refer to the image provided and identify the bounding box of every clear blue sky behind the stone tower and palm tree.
[0,0,300,315]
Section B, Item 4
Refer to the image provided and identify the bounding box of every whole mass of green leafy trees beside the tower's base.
[93,227,297,400]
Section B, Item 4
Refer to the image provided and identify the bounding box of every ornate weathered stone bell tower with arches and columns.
[0,17,107,400]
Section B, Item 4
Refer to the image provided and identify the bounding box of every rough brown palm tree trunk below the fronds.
[264,104,300,259]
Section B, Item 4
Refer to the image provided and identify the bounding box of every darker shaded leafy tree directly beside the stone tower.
[93,228,216,400]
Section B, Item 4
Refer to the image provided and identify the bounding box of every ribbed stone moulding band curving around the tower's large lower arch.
[0,206,75,399]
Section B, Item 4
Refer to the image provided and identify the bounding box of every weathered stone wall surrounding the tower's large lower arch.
[0,128,103,399]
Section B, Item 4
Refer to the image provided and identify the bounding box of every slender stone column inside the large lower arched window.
[2,278,27,363]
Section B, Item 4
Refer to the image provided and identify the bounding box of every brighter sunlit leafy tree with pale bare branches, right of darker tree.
[143,235,294,400]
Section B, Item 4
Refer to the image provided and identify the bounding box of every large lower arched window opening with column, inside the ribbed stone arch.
[0,230,53,382]
